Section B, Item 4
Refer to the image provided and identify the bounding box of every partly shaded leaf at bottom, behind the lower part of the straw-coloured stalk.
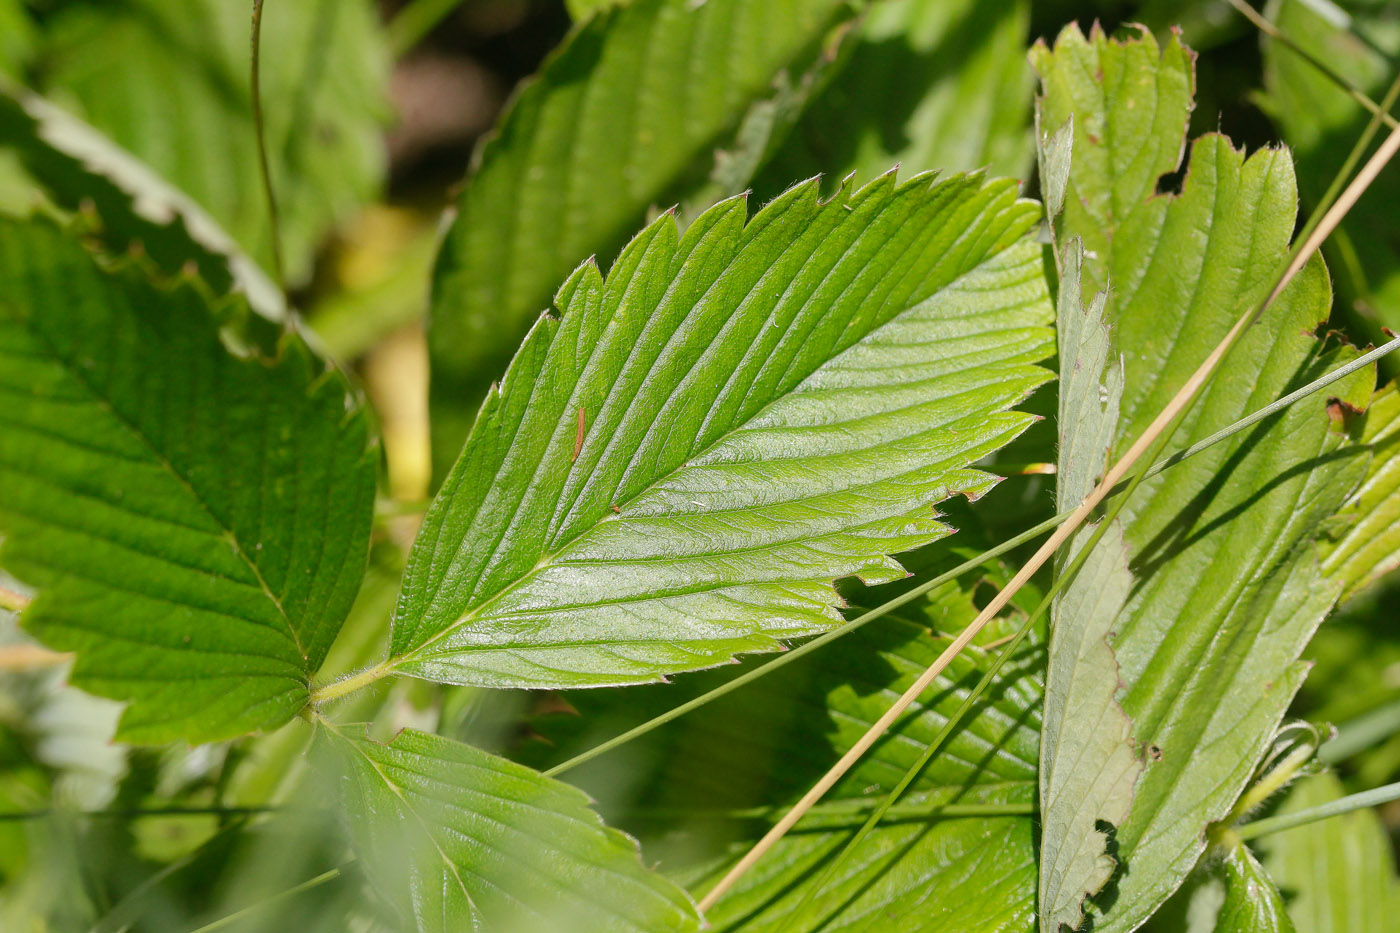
[655,619,1044,933]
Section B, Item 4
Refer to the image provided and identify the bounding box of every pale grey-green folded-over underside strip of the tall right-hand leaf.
[1039,228,1142,930]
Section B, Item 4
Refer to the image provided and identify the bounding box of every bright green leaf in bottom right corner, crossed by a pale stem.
[1256,773,1400,933]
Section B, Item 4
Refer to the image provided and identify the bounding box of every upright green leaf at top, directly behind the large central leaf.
[428,0,850,471]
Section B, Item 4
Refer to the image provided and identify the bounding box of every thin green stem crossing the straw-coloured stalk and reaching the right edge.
[545,330,1400,776]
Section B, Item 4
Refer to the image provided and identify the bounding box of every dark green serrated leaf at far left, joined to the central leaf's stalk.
[0,220,377,742]
